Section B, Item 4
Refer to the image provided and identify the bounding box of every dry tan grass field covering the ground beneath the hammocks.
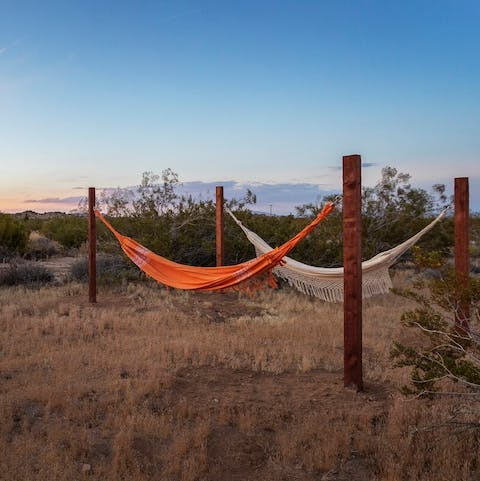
[0,272,480,481]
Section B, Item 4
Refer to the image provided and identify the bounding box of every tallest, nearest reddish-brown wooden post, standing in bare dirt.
[343,155,363,391]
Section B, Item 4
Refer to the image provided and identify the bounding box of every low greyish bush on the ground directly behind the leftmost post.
[70,255,144,284]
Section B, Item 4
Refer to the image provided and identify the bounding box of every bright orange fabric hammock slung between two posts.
[95,203,334,291]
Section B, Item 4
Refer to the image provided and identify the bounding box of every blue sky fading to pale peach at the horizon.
[0,0,480,211]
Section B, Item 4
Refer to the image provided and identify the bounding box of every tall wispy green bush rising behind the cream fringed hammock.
[294,167,453,266]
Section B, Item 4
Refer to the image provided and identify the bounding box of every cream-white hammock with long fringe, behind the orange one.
[227,209,448,302]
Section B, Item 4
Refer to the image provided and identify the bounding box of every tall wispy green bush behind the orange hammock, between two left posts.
[94,179,254,266]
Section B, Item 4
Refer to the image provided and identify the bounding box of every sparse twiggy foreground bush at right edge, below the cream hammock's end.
[391,251,480,396]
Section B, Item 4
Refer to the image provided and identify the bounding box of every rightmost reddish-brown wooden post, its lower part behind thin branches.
[454,177,470,330]
